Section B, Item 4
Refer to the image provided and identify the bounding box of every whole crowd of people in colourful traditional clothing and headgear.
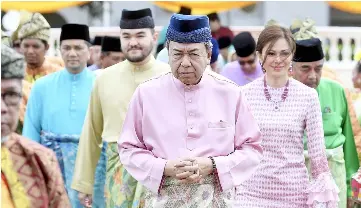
[1,7,361,208]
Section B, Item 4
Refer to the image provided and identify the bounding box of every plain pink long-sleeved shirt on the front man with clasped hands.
[118,70,262,193]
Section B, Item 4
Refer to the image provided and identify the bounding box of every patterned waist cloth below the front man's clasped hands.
[144,175,235,208]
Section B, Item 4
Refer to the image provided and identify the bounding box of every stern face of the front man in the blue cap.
[169,41,212,85]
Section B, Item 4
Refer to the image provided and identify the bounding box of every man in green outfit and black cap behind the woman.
[292,38,359,208]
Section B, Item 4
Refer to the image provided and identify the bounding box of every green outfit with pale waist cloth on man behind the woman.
[304,78,359,208]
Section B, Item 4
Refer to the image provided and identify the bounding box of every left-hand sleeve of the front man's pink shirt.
[118,88,166,193]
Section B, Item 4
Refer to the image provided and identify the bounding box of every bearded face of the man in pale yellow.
[120,28,157,63]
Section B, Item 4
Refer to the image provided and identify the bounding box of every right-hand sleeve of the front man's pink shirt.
[214,93,263,191]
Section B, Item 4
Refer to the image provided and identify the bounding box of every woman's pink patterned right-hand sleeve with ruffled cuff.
[306,91,339,208]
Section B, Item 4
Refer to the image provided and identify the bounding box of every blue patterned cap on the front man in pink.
[166,14,212,43]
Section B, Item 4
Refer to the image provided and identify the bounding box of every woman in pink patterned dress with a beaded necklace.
[236,26,338,208]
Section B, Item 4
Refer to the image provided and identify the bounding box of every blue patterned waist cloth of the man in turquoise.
[40,131,107,208]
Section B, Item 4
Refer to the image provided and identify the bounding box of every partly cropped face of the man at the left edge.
[1,79,22,137]
